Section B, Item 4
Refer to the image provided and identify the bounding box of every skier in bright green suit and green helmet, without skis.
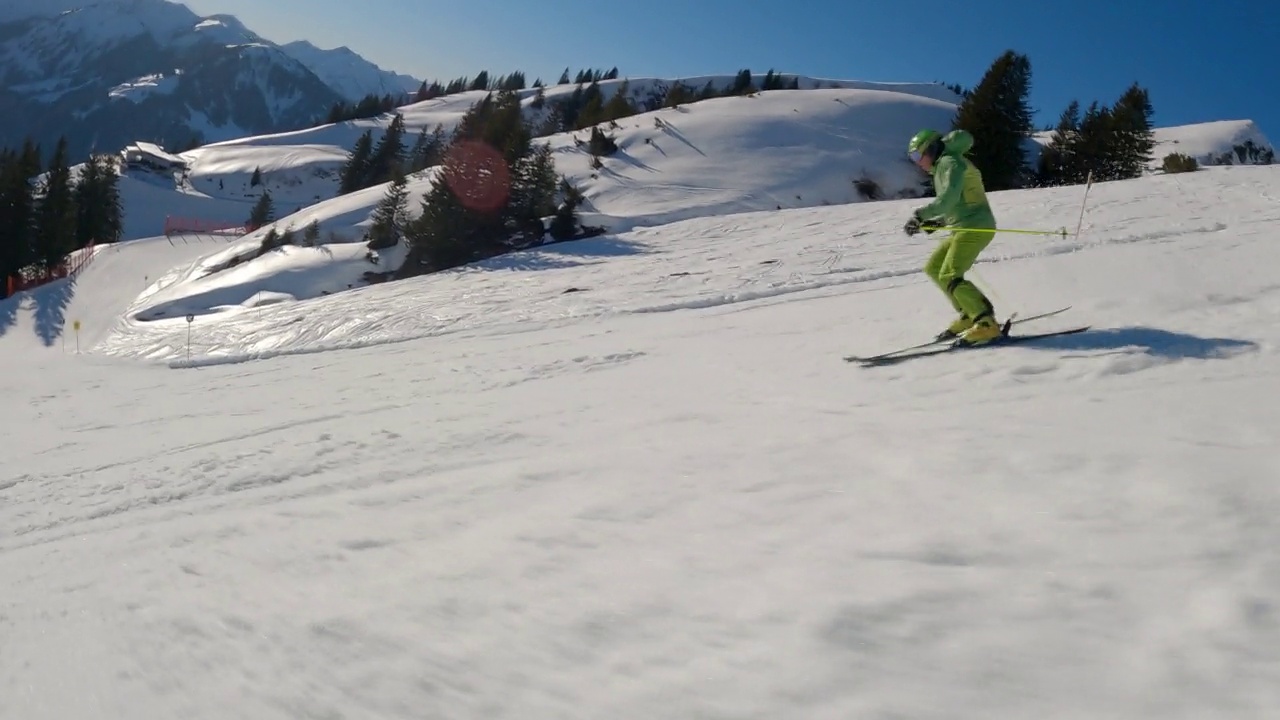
[902,129,1001,345]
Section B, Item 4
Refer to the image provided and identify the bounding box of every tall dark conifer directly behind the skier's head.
[952,50,1033,191]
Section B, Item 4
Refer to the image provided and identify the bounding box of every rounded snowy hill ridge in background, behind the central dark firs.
[183,79,955,222]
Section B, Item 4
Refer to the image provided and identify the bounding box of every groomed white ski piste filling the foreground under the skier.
[0,74,1280,720]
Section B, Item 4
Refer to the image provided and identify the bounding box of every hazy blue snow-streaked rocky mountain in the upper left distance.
[0,0,422,156]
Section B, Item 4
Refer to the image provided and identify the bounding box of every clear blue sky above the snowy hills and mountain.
[184,0,1280,142]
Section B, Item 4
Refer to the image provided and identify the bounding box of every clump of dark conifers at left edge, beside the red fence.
[0,137,124,288]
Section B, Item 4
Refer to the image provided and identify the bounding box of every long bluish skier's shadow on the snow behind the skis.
[1024,327,1258,360]
